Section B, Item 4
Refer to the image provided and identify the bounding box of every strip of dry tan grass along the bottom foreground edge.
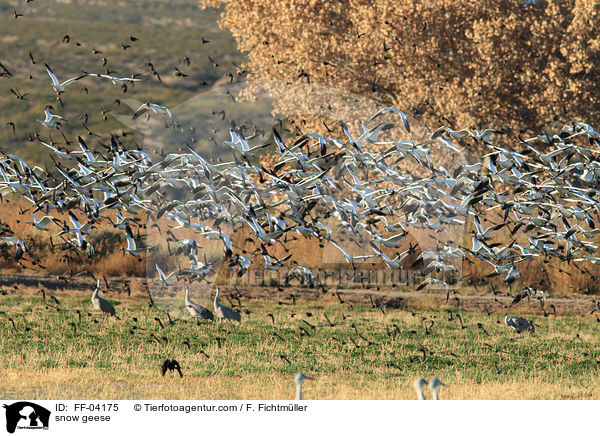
[0,369,600,400]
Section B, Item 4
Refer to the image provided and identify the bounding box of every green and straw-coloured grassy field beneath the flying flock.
[0,288,600,399]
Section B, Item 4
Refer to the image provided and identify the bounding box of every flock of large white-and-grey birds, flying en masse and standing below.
[0,43,600,399]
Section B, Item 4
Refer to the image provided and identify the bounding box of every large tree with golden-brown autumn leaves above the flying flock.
[201,0,600,135]
